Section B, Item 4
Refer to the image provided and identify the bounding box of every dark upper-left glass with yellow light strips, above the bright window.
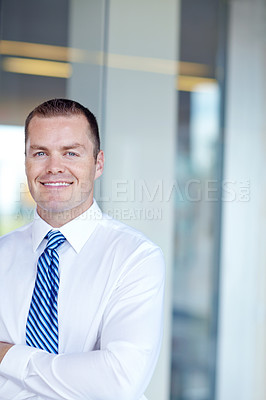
[0,0,69,125]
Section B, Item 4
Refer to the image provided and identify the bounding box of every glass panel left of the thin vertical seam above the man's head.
[0,0,105,234]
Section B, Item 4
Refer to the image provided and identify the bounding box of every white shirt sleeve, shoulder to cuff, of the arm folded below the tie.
[0,248,165,400]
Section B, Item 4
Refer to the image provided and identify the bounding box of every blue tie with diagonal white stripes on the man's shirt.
[26,231,66,353]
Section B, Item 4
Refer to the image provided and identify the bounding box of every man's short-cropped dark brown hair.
[25,99,100,161]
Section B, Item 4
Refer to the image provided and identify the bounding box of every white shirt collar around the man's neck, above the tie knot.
[32,200,102,253]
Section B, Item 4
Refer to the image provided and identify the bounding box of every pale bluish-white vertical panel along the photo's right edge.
[216,0,266,400]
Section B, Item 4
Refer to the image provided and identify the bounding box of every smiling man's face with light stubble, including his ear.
[26,115,104,222]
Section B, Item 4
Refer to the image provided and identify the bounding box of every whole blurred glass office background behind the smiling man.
[0,0,266,400]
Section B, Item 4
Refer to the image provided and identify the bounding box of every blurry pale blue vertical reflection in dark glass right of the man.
[173,84,219,400]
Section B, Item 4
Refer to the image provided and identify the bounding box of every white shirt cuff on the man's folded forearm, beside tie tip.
[0,344,42,386]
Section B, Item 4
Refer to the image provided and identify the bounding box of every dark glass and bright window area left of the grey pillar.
[0,0,71,234]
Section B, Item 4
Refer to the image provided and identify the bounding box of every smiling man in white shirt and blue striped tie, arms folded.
[0,99,164,400]
